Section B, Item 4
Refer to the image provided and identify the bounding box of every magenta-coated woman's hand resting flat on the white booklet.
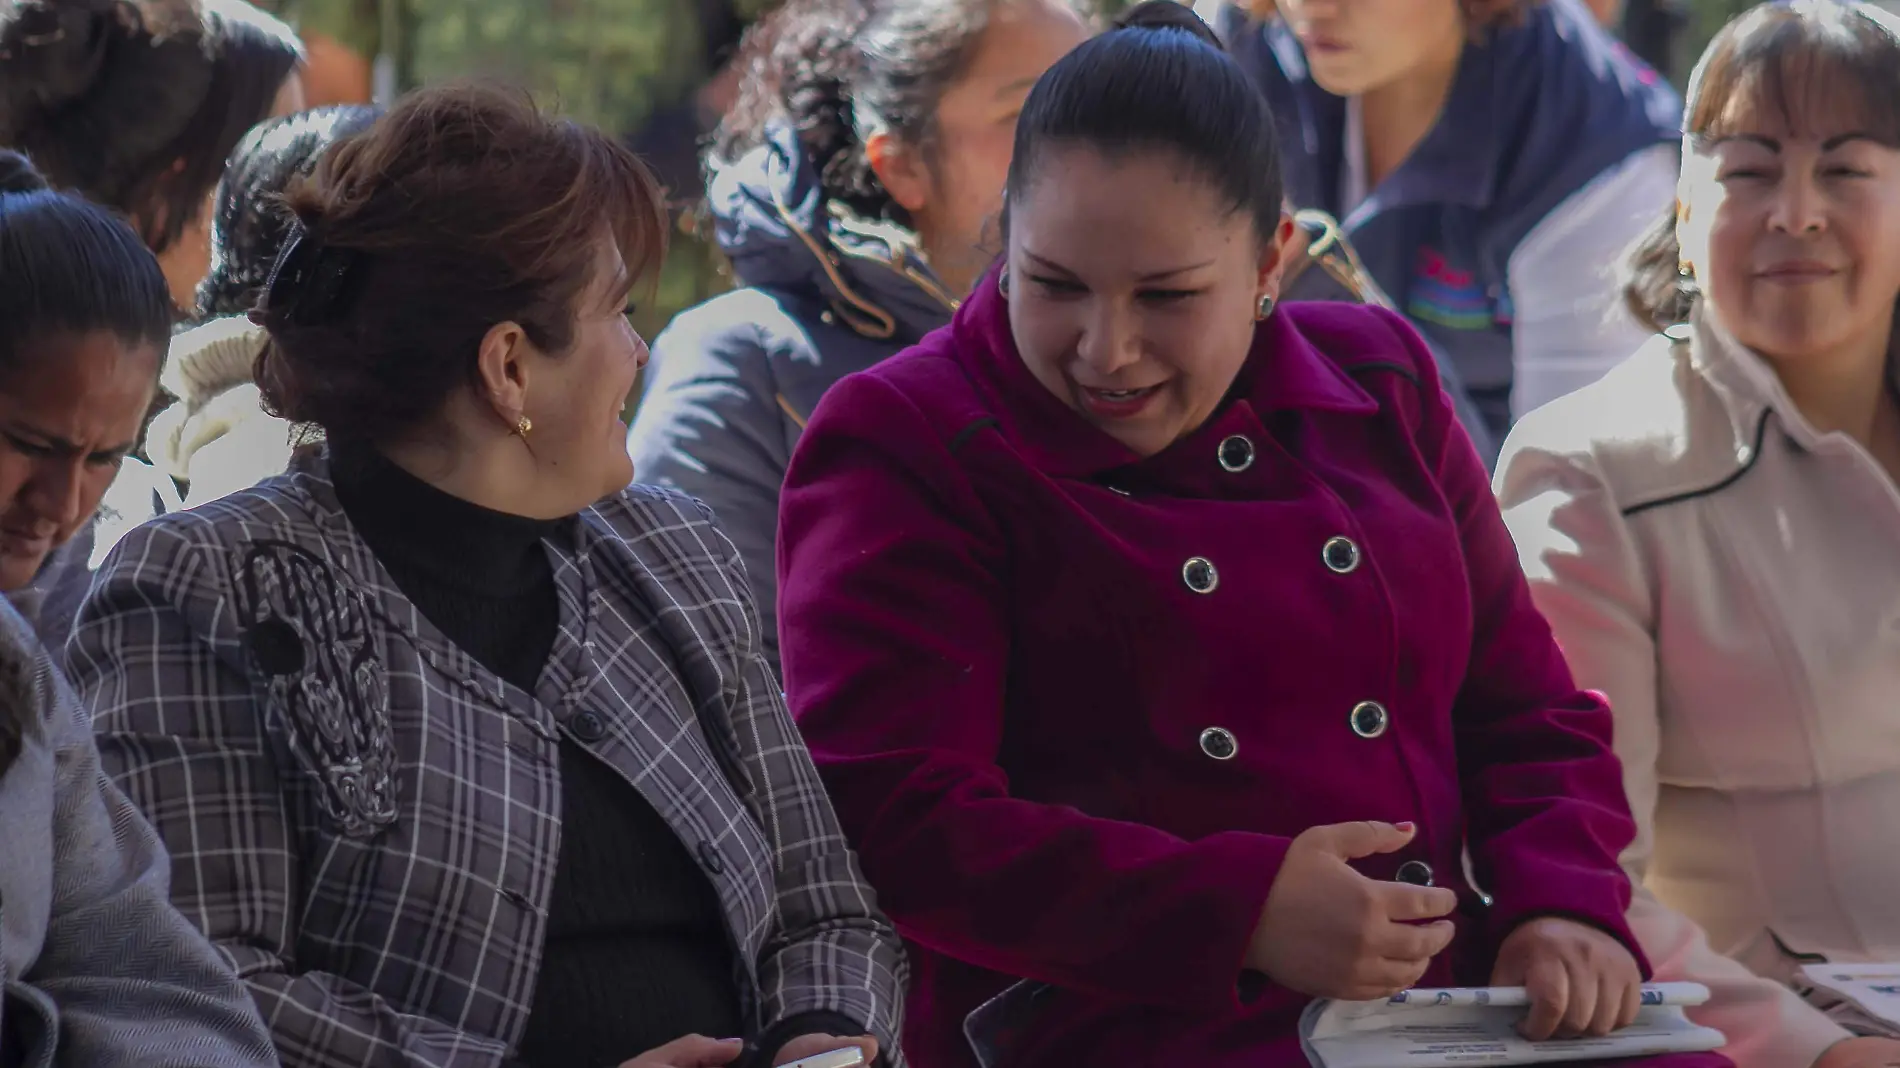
[1492,916,1644,1041]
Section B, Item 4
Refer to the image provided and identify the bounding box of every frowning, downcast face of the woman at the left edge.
[0,331,158,593]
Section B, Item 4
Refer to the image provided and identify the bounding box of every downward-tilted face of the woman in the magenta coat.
[1007,146,1290,456]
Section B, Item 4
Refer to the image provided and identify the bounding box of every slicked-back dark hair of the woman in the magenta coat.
[1003,0,1283,241]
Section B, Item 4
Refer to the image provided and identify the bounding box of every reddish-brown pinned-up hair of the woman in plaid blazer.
[253,86,667,441]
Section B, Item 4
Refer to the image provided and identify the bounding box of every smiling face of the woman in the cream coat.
[1678,81,1900,361]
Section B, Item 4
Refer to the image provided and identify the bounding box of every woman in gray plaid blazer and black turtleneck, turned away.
[68,87,904,1068]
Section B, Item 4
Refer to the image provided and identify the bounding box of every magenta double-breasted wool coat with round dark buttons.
[779,277,1725,1068]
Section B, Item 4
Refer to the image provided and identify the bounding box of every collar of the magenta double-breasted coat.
[948,266,1379,479]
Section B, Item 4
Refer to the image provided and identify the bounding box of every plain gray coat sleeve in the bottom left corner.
[0,601,277,1068]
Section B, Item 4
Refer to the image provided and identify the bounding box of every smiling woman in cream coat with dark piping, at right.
[1497,0,1900,1068]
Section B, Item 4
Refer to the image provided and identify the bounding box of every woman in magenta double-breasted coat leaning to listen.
[779,8,1723,1068]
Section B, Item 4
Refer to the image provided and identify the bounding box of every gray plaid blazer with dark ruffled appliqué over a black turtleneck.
[67,458,906,1068]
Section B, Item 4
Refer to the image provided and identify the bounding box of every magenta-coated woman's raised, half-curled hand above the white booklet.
[1246,821,1457,1001]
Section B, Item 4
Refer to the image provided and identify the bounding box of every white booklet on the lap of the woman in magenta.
[1300,982,1727,1068]
